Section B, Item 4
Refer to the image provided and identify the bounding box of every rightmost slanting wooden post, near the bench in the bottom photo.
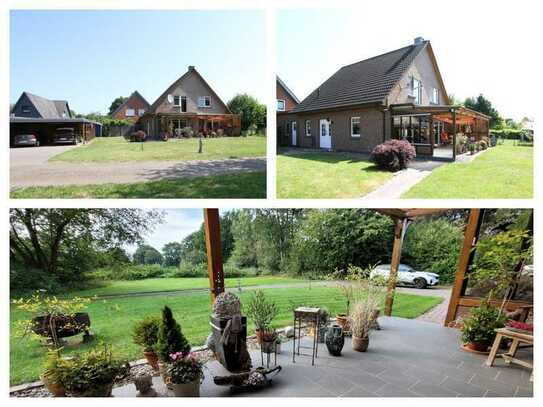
[445,209,482,326]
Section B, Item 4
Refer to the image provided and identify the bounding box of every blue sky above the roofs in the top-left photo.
[10,10,266,113]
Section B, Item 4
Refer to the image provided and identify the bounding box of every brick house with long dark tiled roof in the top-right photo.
[277,37,489,160]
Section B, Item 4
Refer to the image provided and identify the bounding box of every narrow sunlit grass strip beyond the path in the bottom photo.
[68,276,306,297]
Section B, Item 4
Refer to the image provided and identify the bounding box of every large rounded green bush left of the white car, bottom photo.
[289,209,393,275]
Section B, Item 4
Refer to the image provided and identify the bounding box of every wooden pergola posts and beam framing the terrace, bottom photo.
[204,208,533,326]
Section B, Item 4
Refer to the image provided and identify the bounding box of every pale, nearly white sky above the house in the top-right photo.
[277,5,541,119]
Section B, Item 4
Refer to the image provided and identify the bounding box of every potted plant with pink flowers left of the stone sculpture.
[167,352,204,397]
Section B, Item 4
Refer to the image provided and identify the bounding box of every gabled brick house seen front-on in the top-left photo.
[139,66,241,138]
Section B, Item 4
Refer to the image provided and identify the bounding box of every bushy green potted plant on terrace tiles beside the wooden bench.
[462,301,507,352]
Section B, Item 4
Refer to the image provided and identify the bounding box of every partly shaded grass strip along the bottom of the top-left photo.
[10,172,266,199]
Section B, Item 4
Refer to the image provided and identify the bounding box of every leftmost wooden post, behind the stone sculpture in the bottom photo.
[204,209,224,302]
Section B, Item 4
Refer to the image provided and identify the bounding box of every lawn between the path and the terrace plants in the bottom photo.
[10,287,442,385]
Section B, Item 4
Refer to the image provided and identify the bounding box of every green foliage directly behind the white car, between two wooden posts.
[402,218,464,283]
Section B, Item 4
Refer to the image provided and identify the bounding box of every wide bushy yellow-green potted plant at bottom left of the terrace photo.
[58,346,128,397]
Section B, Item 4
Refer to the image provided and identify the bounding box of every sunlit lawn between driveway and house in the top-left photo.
[50,136,266,163]
